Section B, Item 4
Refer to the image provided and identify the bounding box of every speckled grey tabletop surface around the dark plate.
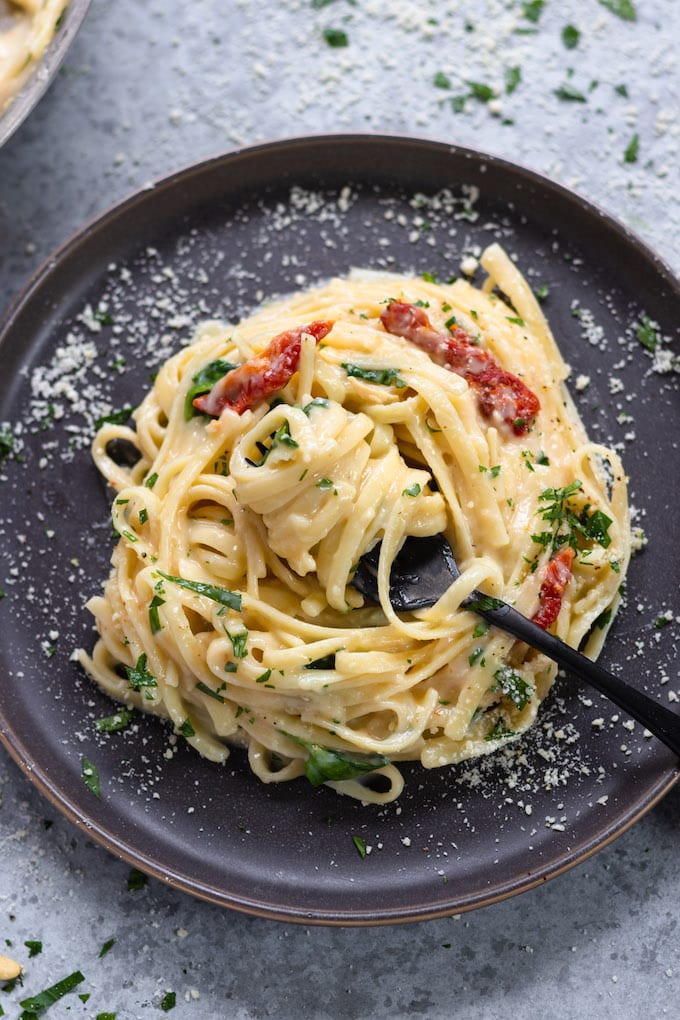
[0,0,680,1020]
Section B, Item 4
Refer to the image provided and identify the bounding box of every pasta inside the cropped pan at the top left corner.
[0,0,67,113]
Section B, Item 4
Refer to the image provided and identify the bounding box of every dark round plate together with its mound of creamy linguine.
[0,136,680,924]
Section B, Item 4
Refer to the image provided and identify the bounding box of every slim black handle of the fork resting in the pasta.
[463,592,680,756]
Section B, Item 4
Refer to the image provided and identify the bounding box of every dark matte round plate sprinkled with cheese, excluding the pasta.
[0,136,680,924]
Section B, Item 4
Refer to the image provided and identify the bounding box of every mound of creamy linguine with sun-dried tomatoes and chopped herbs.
[79,245,630,803]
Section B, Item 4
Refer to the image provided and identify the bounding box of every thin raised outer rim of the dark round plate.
[0,133,680,926]
